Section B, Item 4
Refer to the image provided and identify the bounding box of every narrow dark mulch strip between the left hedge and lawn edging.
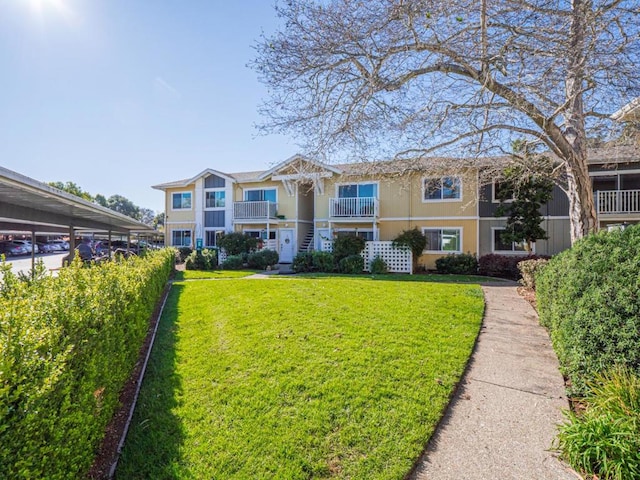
[87,283,171,480]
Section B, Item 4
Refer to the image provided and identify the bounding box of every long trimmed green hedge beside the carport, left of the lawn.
[0,249,175,479]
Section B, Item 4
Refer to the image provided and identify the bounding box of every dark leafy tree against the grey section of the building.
[495,158,553,252]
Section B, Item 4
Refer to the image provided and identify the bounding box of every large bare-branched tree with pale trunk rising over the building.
[253,0,640,240]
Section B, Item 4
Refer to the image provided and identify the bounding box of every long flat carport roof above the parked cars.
[0,167,154,233]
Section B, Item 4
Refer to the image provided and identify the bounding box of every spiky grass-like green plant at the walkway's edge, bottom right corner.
[557,368,640,480]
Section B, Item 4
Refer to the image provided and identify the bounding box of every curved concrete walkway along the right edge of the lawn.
[409,285,580,480]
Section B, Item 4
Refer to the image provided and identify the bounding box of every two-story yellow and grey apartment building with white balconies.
[154,146,640,268]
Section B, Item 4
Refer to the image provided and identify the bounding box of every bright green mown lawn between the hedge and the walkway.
[117,277,483,479]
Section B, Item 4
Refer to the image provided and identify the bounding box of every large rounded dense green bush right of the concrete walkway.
[536,225,640,395]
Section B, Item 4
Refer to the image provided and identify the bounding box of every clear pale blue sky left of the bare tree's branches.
[0,0,298,211]
